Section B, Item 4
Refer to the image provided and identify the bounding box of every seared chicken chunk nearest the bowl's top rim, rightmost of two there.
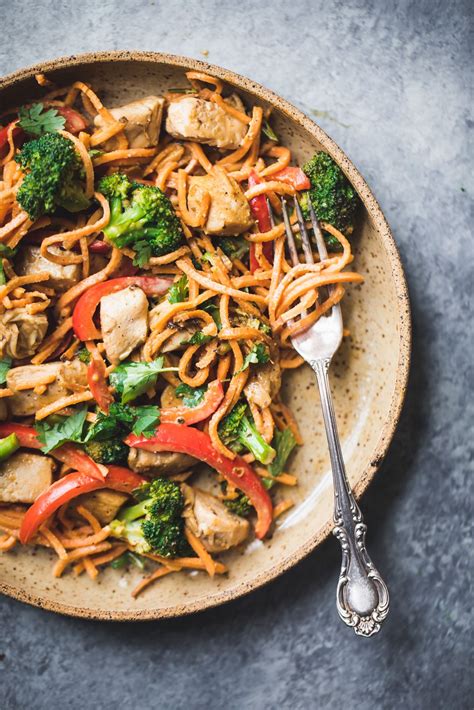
[166,94,247,150]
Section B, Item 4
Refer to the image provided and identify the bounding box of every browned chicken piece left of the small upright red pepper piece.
[7,360,87,417]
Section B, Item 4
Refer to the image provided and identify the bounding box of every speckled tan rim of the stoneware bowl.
[0,50,411,621]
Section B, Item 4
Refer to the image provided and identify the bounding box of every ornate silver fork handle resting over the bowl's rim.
[310,358,389,636]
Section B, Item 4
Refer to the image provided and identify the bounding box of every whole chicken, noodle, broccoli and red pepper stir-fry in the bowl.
[0,71,362,596]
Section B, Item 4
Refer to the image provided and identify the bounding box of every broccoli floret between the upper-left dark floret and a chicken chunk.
[99,173,183,266]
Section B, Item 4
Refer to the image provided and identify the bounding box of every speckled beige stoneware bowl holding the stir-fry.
[0,52,411,620]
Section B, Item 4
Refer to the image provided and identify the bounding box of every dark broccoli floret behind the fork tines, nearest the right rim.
[301,151,360,250]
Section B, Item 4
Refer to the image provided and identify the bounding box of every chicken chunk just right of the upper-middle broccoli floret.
[188,167,253,236]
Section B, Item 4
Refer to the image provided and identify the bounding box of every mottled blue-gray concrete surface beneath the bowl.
[0,0,474,710]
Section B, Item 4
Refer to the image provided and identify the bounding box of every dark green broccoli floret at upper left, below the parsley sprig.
[15,133,90,219]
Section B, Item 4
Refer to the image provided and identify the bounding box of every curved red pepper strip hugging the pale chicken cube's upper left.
[72,276,172,340]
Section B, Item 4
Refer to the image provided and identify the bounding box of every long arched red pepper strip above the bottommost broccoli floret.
[125,424,273,538]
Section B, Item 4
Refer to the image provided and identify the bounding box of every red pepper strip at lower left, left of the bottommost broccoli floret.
[20,466,146,545]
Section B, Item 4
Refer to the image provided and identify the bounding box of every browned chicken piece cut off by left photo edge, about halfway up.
[0,308,48,360]
